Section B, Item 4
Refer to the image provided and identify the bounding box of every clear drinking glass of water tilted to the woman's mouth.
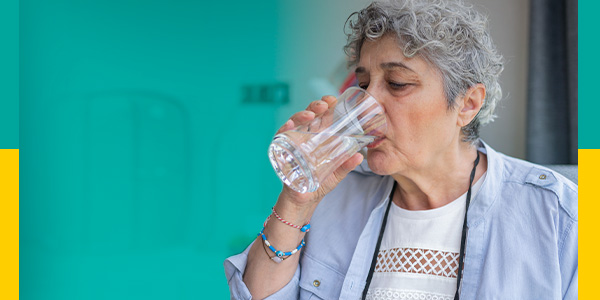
[269,87,386,193]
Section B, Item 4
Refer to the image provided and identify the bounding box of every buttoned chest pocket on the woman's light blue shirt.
[300,255,345,300]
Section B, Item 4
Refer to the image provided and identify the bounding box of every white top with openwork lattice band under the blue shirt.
[367,173,486,300]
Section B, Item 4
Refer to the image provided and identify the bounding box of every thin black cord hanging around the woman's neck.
[362,151,479,300]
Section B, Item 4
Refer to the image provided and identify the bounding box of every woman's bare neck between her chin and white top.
[392,142,487,210]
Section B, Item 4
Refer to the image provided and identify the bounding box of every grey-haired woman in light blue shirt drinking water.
[225,0,578,299]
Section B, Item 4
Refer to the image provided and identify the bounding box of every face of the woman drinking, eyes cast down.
[355,35,460,175]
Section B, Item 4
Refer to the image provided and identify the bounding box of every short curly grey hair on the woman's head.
[344,0,504,143]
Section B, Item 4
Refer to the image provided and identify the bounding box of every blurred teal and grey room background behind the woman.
[17,0,577,300]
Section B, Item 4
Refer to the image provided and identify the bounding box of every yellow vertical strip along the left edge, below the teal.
[0,149,19,299]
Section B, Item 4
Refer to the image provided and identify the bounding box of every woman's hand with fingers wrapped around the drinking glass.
[277,96,363,214]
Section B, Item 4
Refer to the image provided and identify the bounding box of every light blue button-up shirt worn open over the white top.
[225,142,578,300]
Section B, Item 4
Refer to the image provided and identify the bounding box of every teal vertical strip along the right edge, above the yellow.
[578,0,600,149]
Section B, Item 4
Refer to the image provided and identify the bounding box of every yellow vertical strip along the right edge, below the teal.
[579,149,600,299]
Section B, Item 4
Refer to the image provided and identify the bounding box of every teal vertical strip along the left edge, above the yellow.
[0,0,19,149]
